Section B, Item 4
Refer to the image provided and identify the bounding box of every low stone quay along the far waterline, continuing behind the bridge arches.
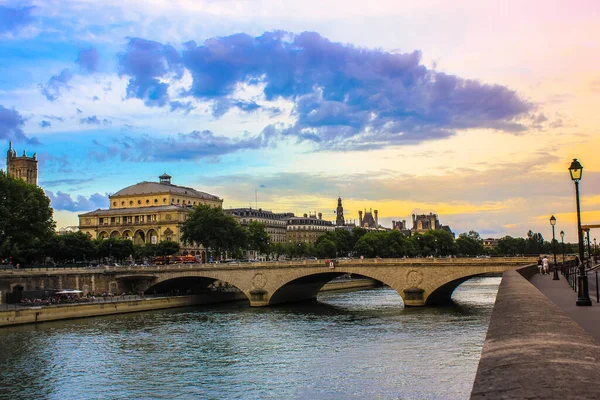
[0,279,379,327]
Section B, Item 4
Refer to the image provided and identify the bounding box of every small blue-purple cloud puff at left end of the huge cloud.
[118,38,183,107]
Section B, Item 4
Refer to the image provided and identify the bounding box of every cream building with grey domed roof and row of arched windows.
[79,173,223,261]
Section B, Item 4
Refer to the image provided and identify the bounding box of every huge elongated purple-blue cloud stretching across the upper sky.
[119,31,534,150]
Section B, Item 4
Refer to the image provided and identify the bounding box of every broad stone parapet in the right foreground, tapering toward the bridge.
[471,266,600,399]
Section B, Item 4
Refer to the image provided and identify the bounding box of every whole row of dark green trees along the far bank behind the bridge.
[0,171,592,265]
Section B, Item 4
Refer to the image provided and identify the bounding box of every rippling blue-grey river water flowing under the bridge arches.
[0,278,500,399]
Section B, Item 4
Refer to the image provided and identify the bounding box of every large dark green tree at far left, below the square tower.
[0,171,55,258]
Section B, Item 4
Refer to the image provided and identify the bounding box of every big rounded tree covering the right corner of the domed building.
[181,205,246,255]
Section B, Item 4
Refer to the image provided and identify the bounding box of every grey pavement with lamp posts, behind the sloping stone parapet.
[529,271,600,343]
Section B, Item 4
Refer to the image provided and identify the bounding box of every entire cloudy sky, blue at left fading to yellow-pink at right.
[0,0,600,241]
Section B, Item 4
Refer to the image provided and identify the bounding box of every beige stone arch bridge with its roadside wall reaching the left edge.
[0,257,536,307]
